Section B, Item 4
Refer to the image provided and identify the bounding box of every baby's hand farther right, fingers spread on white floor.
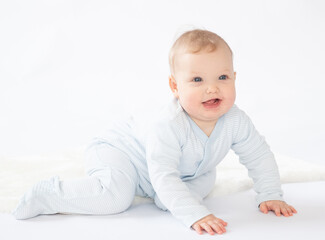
[260,200,297,217]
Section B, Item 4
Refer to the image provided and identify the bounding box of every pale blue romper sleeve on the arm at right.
[231,111,283,206]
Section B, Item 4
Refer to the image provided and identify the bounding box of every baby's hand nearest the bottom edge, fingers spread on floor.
[192,214,227,235]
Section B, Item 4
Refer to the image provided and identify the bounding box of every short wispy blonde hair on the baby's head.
[169,29,233,75]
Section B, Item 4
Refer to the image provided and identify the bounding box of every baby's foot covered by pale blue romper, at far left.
[12,176,59,219]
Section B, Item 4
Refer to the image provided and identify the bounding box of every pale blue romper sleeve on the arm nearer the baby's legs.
[146,120,211,227]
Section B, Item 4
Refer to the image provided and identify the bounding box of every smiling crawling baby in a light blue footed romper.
[13,29,297,235]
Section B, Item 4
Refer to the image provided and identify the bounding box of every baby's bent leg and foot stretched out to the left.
[13,143,138,219]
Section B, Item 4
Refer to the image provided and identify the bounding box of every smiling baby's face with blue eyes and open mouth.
[169,45,236,127]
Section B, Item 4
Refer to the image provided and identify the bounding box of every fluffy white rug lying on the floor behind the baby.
[0,147,325,213]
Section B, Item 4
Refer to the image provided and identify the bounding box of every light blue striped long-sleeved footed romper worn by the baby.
[13,98,283,227]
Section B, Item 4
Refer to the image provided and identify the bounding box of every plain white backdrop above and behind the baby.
[0,0,325,163]
